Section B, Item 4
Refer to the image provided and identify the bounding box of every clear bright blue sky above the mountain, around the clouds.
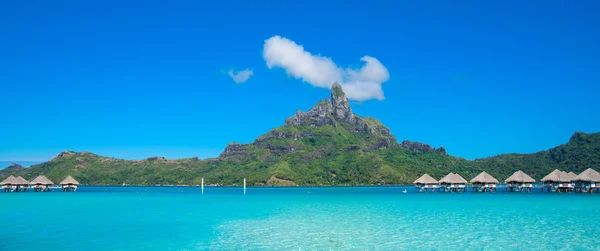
[0,0,600,160]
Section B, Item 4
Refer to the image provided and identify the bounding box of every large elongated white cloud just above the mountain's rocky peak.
[263,36,390,101]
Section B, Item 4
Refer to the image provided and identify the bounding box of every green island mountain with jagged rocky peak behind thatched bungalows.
[0,84,600,186]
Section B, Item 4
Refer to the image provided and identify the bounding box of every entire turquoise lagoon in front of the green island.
[0,187,600,251]
